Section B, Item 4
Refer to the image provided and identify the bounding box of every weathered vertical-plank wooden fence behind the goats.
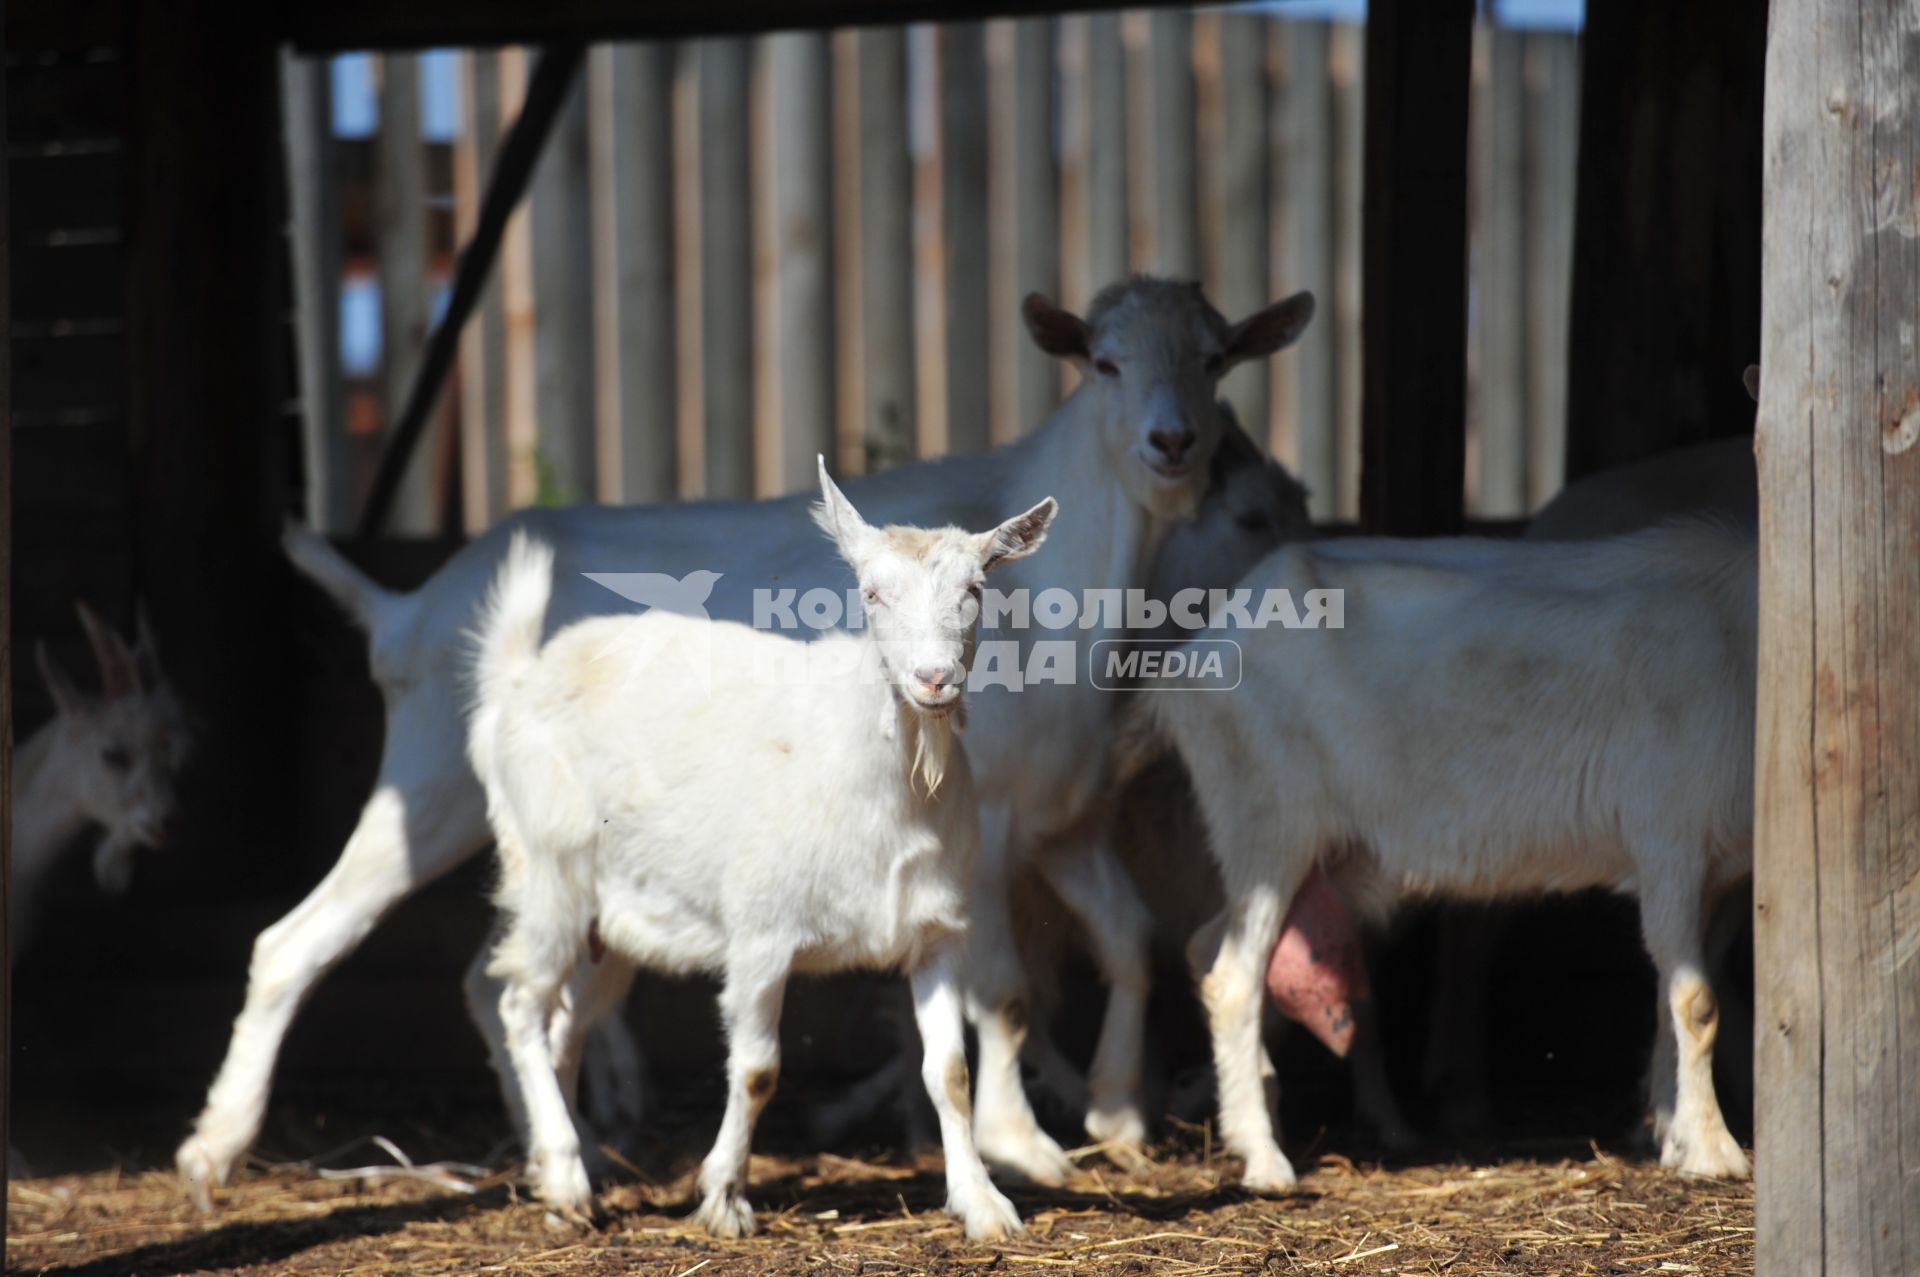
[288,10,1578,534]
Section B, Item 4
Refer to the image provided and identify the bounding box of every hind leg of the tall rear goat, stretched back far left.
[175,714,488,1210]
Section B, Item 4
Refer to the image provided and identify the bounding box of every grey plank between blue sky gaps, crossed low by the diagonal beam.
[374,54,444,536]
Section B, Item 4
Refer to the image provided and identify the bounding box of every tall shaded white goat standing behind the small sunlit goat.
[177,278,1313,1208]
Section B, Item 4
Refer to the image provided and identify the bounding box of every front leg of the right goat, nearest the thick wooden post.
[1640,849,1749,1179]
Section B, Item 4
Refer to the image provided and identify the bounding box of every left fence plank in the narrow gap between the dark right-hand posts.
[1475,27,1526,518]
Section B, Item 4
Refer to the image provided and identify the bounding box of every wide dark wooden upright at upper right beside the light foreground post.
[1567,0,1766,478]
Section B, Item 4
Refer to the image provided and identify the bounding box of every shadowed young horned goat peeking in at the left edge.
[10,603,194,952]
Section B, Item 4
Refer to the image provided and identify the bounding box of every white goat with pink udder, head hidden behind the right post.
[1142,522,1757,1191]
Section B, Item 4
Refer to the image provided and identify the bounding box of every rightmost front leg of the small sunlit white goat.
[910,941,1020,1241]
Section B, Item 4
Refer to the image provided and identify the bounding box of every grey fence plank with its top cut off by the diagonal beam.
[528,65,597,505]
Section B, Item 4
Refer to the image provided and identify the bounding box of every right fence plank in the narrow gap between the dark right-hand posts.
[1521,31,1580,511]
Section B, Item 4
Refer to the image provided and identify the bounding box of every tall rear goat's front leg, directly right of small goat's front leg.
[968,808,1073,1185]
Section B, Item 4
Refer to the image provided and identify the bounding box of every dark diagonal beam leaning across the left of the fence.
[359,44,586,536]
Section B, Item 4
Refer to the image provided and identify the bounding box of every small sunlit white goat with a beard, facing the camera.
[468,463,1056,1239]
